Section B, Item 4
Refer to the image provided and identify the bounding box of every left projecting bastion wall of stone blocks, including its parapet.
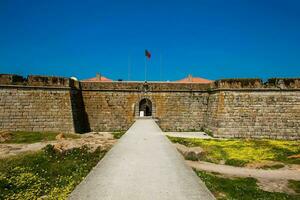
[0,75,74,132]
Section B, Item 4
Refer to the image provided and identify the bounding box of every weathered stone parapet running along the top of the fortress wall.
[0,74,300,92]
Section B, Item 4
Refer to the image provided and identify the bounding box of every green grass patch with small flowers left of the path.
[0,145,106,200]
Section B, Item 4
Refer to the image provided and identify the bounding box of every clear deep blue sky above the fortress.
[0,0,300,80]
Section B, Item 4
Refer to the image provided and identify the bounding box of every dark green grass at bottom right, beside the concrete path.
[195,171,300,200]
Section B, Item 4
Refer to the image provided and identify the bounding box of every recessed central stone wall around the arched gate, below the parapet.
[83,91,208,131]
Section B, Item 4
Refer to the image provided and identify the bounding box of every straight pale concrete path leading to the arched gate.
[69,119,214,200]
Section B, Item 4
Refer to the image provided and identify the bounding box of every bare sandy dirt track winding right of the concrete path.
[174,144,300,194]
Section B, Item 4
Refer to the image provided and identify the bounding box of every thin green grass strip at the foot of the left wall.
[3,131,80,144]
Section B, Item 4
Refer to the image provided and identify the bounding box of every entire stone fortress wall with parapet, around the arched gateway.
[0,74,300,139]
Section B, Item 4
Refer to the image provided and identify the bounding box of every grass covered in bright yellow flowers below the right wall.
[169,137,300,168]
